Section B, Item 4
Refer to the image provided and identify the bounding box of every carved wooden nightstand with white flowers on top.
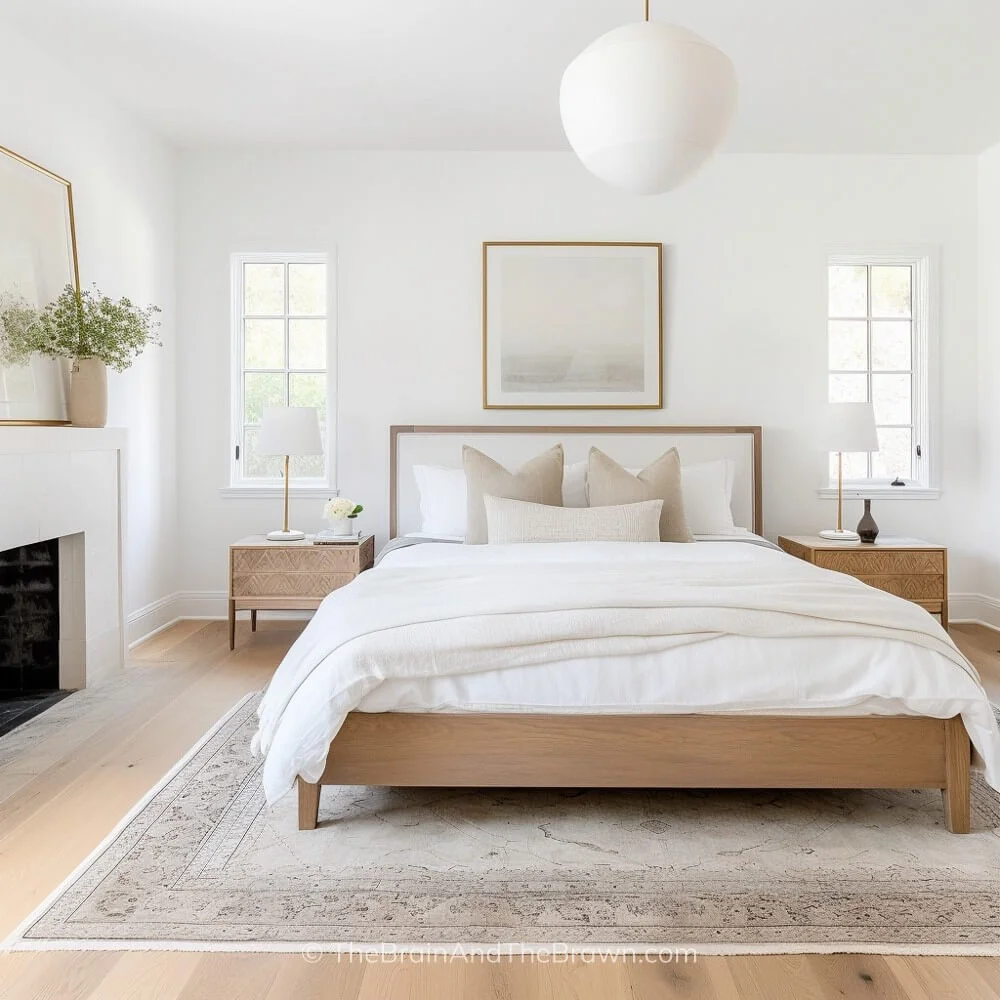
[229,535,375,649]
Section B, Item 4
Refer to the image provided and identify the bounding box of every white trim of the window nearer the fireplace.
[225,251,338,500]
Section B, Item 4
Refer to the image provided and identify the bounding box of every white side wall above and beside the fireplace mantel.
[0,25,177,634]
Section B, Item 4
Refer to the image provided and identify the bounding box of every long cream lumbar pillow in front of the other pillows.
[483,496,663,545]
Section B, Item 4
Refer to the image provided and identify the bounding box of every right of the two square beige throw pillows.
[587,448,694,542]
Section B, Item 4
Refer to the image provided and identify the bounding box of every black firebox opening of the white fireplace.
[0,539,68,735]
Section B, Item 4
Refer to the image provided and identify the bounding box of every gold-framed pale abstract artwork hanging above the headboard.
[483,243,663,410]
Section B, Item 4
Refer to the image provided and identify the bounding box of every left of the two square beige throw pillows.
[462,444,564,545]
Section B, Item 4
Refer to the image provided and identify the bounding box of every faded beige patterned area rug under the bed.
[8,696,1000,955]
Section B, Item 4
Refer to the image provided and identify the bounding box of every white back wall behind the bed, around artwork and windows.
[178,150,980,612]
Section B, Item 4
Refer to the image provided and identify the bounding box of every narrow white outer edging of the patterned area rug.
[7,691,1000,962]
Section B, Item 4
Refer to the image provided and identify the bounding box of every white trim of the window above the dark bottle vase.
[816,246,941,500]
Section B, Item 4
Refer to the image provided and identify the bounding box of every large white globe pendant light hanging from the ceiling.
[559,21,737,194]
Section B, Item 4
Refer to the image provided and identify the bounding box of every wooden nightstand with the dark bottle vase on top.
[778,535,948,629]
